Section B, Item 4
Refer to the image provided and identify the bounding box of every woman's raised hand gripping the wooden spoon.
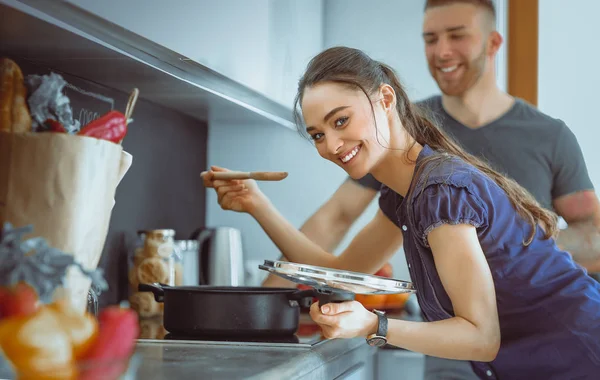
[202,166,266,214]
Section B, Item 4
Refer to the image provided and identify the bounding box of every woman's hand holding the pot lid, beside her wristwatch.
[310,301,378,338]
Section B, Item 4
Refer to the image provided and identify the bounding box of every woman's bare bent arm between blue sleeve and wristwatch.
[388,224,500,361]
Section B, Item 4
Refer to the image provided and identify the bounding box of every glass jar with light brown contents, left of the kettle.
[128,229,176,318]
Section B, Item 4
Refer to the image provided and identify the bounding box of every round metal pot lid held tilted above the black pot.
[258,260,416,294]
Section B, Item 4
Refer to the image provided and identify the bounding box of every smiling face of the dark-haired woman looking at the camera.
[301,82,390,179]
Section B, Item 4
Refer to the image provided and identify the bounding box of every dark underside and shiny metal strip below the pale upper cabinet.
[0,0,295,129]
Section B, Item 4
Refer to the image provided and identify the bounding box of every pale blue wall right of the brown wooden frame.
[538,0,600,189]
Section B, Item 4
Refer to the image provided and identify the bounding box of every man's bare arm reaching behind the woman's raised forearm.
[262,178,377,287]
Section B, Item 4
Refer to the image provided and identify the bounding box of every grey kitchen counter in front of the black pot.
[136,338,377,380]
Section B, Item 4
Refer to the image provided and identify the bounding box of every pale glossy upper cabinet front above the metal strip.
[68,0,323,107]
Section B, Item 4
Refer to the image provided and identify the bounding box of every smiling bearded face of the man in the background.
[423,3,491,96]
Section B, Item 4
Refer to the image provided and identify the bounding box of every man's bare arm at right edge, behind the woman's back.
[553,190,600,272]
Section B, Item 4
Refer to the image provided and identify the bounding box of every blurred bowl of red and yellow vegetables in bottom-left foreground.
[0,223,140,380]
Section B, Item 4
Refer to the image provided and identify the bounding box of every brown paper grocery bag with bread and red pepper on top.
[0,132,125,312]
